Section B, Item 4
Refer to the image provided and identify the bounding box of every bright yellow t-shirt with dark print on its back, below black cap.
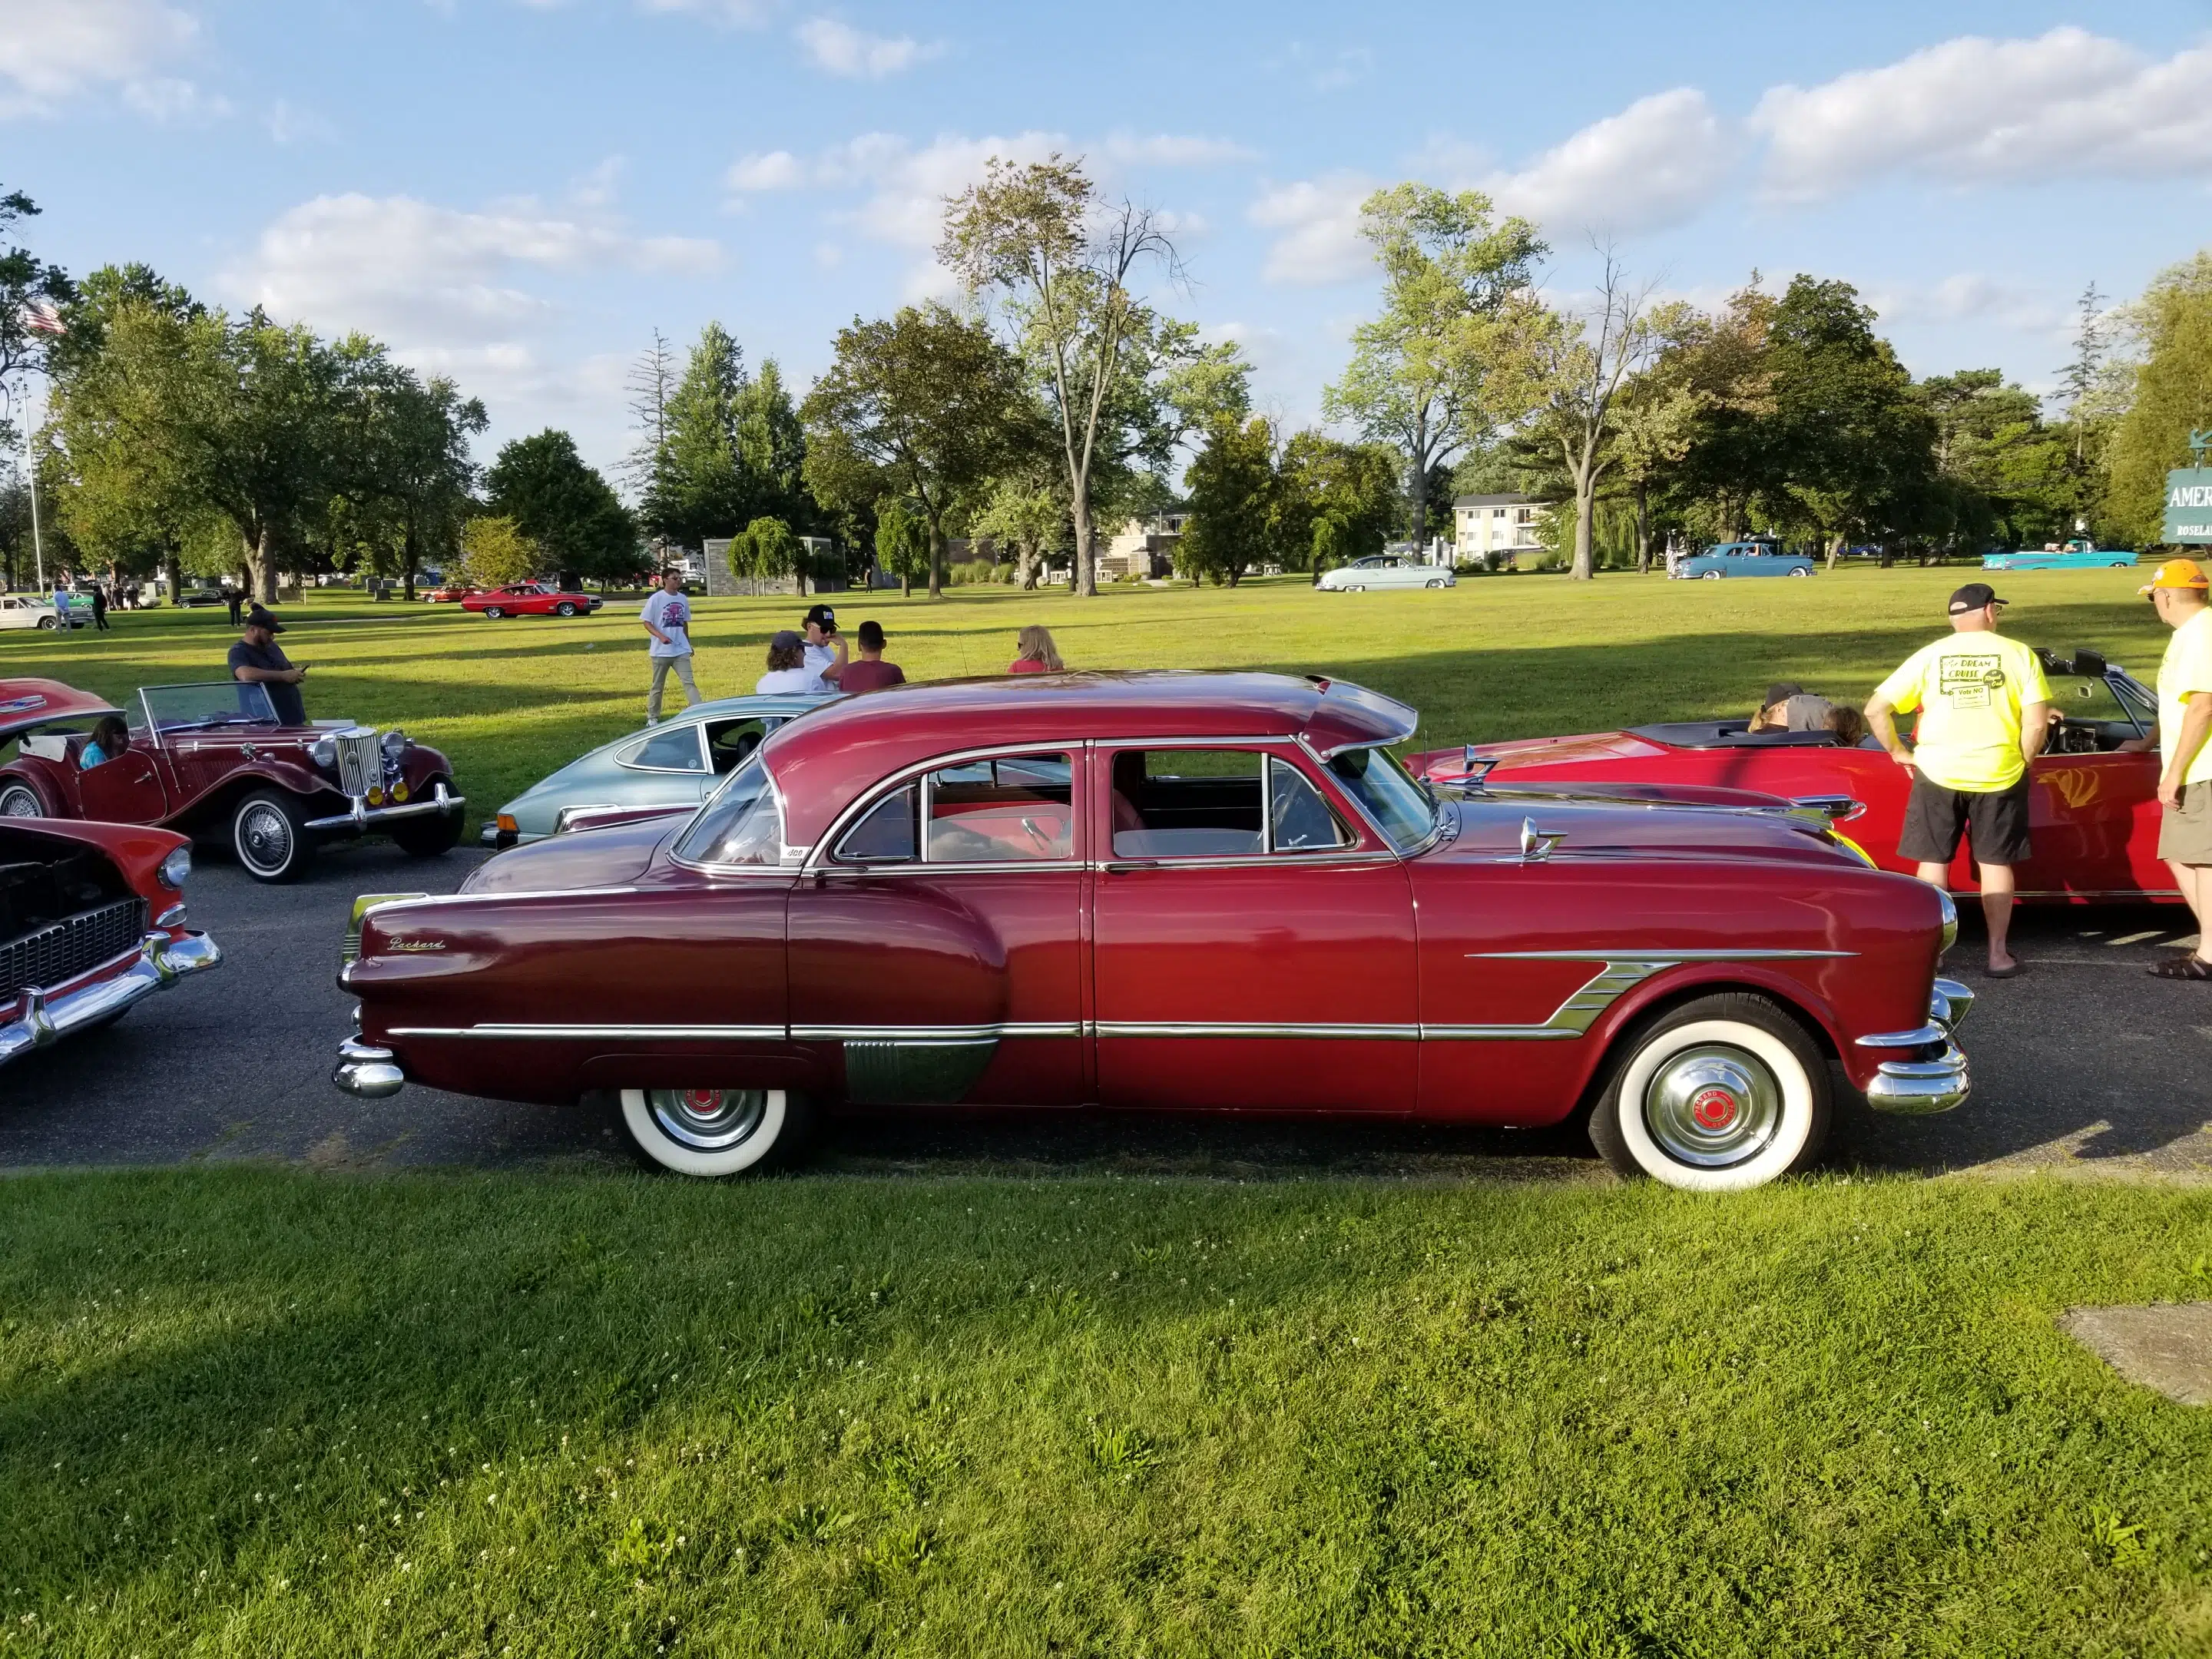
[1873,628,2051,794]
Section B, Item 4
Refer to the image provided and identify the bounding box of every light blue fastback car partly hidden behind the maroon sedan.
[482,697,834,847]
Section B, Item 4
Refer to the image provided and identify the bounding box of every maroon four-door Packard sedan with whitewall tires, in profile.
[336,673,1971,1188]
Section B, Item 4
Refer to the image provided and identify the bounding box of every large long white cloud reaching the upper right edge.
[1752,28,2212,201]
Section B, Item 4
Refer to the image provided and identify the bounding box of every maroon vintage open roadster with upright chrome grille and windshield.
[0,679,465,882]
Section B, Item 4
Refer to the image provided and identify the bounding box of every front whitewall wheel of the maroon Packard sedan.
[1591,991,1830,1192]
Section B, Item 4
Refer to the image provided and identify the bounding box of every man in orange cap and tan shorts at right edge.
[2121,560,2212,980]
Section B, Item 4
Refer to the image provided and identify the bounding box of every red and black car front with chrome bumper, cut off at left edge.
[0,813,224,1064]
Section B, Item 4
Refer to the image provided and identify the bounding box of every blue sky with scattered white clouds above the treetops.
[0,0,2212,479]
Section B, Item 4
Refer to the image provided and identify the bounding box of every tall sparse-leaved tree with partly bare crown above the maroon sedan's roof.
[938,155,1181,598]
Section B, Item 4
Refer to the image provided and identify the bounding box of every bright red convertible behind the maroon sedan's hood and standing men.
[1407,651,2181,902]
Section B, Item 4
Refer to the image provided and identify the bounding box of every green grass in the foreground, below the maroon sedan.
[0,1171,2212,1659]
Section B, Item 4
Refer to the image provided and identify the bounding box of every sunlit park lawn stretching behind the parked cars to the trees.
[0,566,2166,819]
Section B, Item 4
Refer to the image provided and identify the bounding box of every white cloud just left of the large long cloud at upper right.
[1482,86,1741,234]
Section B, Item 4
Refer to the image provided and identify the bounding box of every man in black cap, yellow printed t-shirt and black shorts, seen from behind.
[1867,581,2051,980]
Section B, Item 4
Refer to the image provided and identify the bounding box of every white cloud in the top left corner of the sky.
[0,0,207,120]
